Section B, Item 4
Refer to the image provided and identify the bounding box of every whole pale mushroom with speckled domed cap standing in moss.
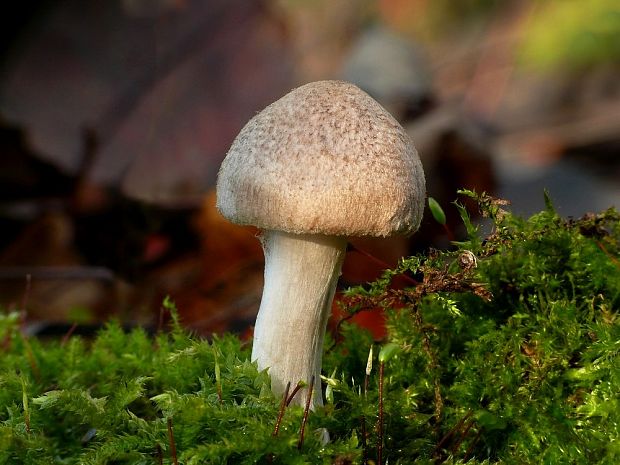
[217,81,425,408]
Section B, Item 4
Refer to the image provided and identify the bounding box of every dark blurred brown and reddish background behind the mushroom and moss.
[0,0,620,338]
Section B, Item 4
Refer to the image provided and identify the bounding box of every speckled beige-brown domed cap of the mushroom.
[217,81,426,236]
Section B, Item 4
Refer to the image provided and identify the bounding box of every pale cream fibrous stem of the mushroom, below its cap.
[252,230,347,409]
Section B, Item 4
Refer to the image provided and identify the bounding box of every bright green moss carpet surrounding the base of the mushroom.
[0,192,620,464]
